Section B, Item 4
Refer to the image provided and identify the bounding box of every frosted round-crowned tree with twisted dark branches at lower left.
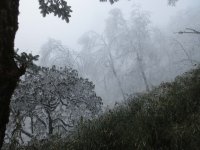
[6,66,102,147]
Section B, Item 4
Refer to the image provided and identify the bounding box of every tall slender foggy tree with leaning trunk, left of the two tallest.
[102,9,126,100]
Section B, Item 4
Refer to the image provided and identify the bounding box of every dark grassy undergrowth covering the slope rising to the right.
[3,67,200,150]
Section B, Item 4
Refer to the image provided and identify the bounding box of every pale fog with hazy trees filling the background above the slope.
[15,0,200,106]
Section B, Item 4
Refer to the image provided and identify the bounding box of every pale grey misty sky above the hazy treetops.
[15,0,200,54]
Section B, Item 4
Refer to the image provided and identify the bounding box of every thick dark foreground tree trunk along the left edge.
[0,0,25,149]
